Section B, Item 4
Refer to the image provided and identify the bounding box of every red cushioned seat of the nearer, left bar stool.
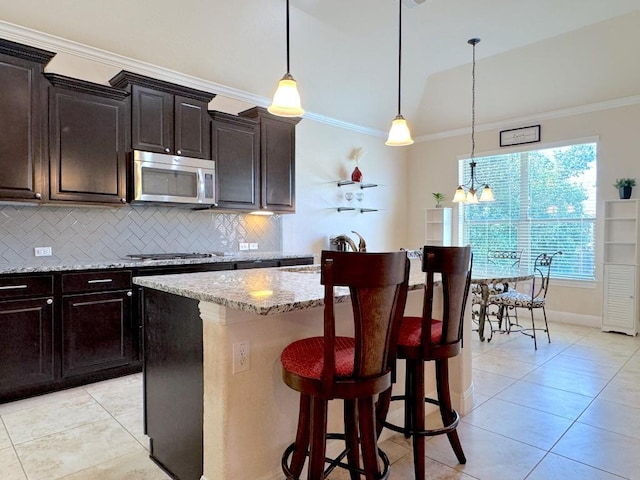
[280,337,355,380]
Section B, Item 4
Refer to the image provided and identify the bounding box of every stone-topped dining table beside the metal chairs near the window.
[471,265,533,342]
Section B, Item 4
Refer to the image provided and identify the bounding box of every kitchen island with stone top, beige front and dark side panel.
[134,259,473,480]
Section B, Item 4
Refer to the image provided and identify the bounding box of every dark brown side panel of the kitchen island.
[143,288,204,480]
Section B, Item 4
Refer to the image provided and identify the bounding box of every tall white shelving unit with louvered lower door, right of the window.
[602,200,640,335]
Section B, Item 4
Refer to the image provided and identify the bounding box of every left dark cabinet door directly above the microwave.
[131,86,174,153]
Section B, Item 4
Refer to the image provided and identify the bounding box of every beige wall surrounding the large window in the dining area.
[407,104,640,316]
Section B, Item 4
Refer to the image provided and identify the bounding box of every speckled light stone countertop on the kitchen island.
[133,259,425,315]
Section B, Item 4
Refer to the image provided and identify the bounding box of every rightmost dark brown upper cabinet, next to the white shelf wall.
[239,107,301,213]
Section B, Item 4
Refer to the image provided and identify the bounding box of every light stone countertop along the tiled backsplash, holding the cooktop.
[0,252,314,275]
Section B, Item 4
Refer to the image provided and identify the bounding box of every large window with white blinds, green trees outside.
[458,143,597,280]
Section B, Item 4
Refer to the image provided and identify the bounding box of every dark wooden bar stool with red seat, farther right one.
[377,246,472,479]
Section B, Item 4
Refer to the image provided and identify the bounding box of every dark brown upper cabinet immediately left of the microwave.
[45,73,129,204]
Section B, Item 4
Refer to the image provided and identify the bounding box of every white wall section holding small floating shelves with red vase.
[282,120,409,253]
